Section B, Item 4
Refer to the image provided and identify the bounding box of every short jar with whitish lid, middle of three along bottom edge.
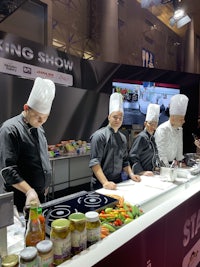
[20,246,38,267]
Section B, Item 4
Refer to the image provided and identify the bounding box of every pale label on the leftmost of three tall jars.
[51,234,71,265]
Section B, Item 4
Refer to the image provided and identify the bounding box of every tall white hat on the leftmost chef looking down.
[27,77,55,114]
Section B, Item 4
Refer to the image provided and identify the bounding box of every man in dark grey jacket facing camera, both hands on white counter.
[89,93,140,190]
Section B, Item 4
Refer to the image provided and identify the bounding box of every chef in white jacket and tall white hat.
[155,94,189,167]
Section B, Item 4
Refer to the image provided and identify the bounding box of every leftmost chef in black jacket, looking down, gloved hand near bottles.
[0,77,55,211]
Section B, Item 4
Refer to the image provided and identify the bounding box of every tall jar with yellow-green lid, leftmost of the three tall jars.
[50,219,71,265]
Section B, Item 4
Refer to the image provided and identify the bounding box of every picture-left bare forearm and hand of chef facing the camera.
[91,164,117,190]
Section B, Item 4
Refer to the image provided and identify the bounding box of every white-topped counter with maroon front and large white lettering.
[60,171,200,267]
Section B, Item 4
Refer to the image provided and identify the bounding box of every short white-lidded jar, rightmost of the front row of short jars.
[36,240,53,267]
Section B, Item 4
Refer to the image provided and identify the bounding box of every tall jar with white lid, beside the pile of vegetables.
[85,211,101,247]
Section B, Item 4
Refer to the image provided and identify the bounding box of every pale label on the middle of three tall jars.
[71,229,87,254]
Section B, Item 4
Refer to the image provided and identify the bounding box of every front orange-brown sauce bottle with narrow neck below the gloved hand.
[25,201,43,247]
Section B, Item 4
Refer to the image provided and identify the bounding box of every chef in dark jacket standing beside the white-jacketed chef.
[129,104,160,176]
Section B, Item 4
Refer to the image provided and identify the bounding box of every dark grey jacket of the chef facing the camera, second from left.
[89,126,130,189]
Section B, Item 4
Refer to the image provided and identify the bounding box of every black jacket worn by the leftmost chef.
[0,114,51,210]
